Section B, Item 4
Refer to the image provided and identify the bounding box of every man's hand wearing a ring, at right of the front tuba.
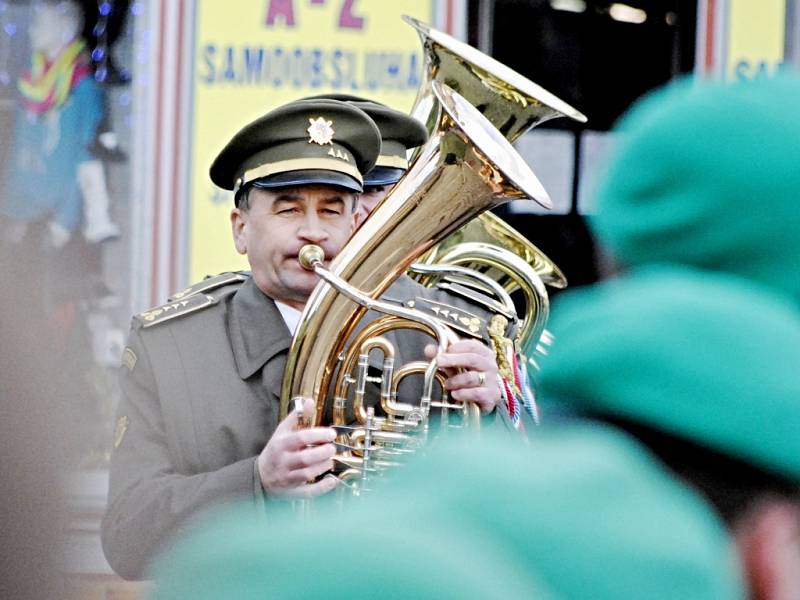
[425,340,502,414]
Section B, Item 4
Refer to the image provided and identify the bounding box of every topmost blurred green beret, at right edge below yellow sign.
[591,73,800,301]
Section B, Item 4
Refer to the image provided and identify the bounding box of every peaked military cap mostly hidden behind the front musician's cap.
[300,94,428,186]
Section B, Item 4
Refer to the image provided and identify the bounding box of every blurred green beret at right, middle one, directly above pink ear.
[539,267,800,481]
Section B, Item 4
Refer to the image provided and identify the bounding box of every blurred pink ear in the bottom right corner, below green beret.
[735,500,800,600]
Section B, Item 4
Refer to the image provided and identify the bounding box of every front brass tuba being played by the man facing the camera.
[281,82,550,482]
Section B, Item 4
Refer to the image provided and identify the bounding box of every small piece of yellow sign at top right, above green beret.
[726,0,786,79]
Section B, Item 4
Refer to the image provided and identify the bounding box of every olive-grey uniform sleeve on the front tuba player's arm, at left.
[101,329,263,579]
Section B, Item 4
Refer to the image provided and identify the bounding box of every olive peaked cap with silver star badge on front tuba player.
[210,99,381,197]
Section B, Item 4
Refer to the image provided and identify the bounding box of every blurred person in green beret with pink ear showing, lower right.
[541,266,800,600]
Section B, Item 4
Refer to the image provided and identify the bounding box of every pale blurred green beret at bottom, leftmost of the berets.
[152,492,553,600]
